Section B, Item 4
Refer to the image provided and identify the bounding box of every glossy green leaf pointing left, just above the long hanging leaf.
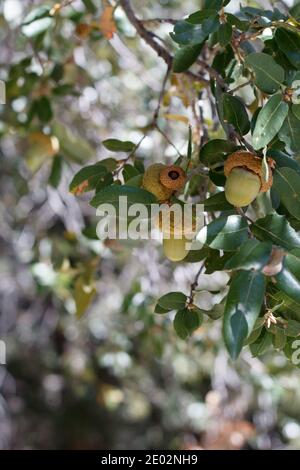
[225,239,272,271]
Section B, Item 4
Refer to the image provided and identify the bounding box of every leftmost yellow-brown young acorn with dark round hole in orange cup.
[143,163,186,202]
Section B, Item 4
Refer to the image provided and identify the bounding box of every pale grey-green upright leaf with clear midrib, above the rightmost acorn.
[252,95,289,149]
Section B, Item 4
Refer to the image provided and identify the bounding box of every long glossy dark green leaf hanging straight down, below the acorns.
[223,271,265,359]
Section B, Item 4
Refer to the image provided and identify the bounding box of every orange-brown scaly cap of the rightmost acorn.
[224,151,275,193]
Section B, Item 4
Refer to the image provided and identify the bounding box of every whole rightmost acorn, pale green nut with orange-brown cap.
[224,151,275,207]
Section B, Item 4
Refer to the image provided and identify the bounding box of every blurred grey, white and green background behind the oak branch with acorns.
[0,0,300,450]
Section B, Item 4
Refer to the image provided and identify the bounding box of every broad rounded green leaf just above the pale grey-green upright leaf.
[245,52,284,94]
